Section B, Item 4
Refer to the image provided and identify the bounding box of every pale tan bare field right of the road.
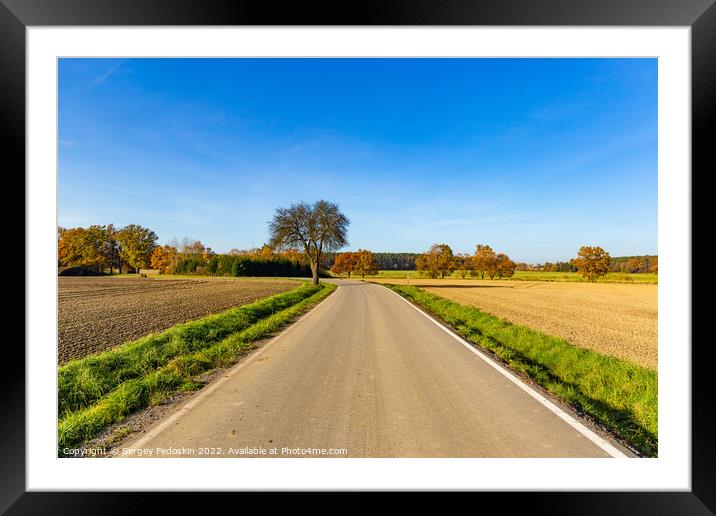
[370,278,658,369]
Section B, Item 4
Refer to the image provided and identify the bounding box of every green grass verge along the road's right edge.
[387,285,658,457]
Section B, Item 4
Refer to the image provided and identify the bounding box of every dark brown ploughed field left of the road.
[57,277,299,364]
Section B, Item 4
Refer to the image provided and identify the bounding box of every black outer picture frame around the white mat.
[0,0,716,515]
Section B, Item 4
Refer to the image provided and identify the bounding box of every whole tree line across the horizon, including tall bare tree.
[58,212,658,283]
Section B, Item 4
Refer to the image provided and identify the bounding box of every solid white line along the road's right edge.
[385,287,628,458]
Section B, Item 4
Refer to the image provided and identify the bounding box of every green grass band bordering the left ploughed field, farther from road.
[57,282,320,417]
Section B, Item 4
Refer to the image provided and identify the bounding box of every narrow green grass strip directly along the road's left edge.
[58,283,336,456]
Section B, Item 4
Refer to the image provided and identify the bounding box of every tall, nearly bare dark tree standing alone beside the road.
[269,200,350,285]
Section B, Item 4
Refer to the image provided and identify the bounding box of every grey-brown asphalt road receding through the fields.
[123,281,619,457]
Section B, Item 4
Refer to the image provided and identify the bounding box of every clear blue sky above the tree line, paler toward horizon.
[58,59,657,263]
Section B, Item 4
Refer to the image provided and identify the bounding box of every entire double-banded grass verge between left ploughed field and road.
[58,283,336,456]
